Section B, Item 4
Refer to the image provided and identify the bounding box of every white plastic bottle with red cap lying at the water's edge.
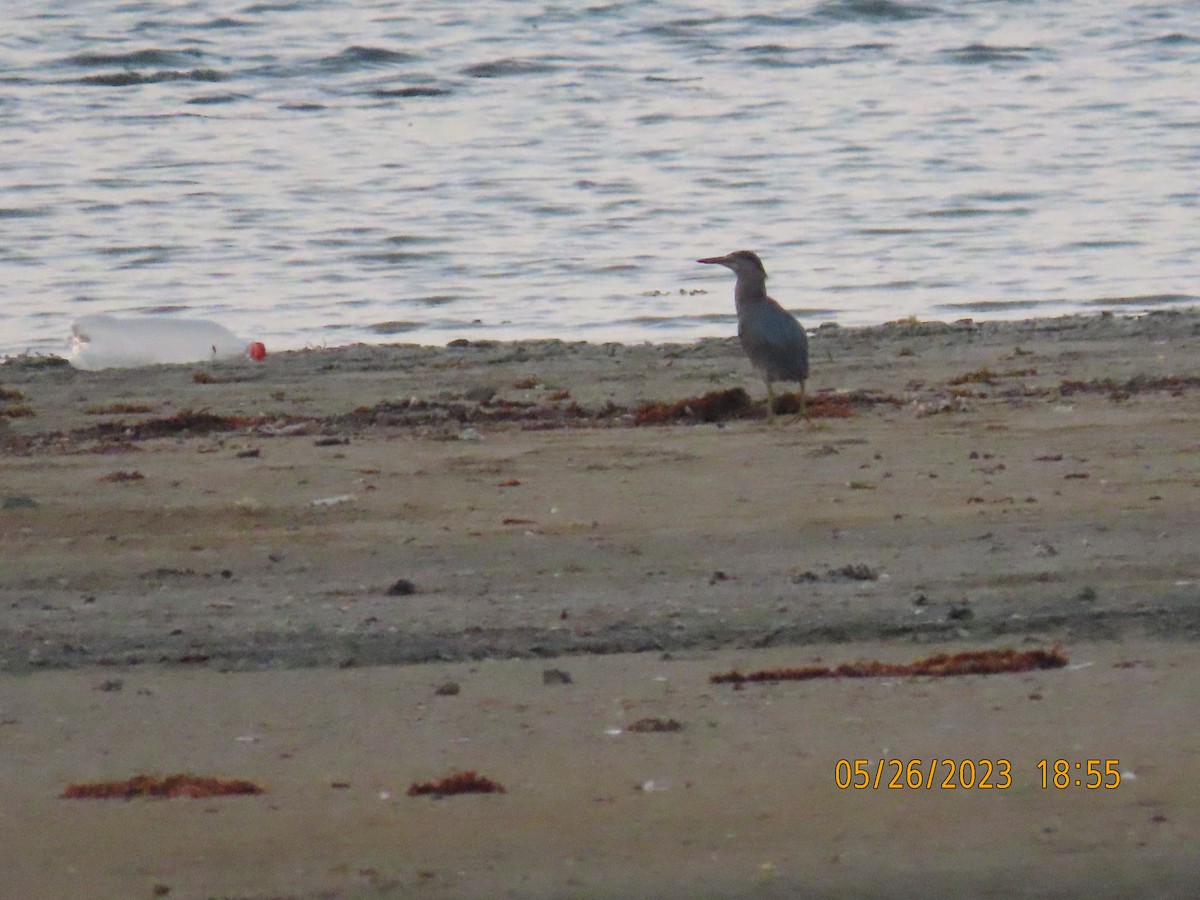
[67,314,266,371]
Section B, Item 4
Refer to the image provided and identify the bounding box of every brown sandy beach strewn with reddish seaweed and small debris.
[0,312,1200,900]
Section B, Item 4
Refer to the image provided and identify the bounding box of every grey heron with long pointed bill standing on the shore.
[696,250,809,415]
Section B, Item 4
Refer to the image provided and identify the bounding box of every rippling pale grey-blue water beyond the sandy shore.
[0,0,1200,353]
